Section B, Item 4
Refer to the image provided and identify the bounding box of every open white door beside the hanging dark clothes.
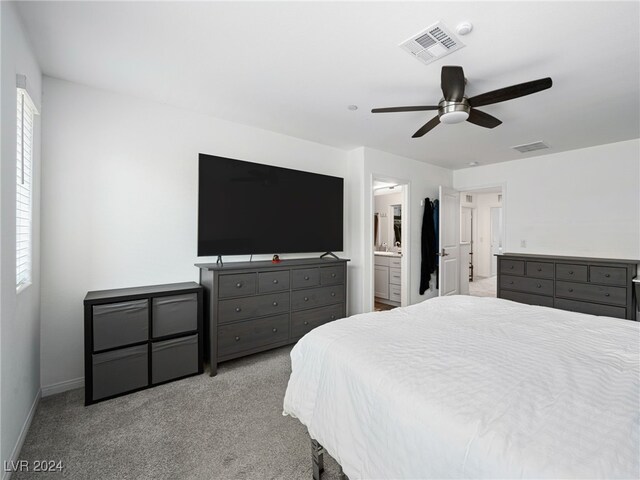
[438,186,460,297]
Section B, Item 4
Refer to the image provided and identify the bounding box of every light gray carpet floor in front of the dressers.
[12,347,338,480]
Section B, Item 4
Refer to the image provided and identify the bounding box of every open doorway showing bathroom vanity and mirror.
[372,177,409,311]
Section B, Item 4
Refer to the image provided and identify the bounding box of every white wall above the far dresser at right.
[453,139,640,259]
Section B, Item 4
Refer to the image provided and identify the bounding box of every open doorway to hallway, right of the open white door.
[460,186,505,297]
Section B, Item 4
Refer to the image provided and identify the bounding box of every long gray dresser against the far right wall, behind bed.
[497,254,640,320]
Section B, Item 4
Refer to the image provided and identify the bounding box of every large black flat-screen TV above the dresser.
[198,154,344,256]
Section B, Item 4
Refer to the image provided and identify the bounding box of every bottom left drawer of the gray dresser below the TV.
[218,314,289,357]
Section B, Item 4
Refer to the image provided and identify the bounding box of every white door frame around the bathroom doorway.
[370,172,411,312]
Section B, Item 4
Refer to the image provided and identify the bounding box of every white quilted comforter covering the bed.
[284,296,640,480]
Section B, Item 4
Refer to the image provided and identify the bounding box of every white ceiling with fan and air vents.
[19,1,640,168]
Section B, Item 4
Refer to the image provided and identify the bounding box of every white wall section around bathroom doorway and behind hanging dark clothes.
[350,147,452,314]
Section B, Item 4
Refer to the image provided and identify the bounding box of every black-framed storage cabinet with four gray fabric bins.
[84,282,204,405]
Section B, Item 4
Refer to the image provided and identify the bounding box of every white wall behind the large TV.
[42,77,348,392]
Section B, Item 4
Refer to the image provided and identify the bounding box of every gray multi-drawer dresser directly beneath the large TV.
[196,258,348,376]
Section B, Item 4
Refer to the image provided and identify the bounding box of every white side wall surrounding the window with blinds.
[0,2,42,472]
